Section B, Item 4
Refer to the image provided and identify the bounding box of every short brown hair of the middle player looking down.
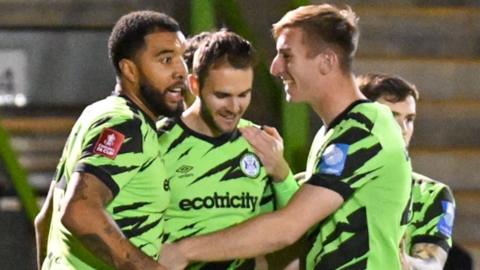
[193,30,255,89]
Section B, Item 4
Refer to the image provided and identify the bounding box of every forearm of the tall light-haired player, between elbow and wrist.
[178,210,301,261]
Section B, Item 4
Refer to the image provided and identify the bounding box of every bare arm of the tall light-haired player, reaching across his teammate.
[160,185,343,269]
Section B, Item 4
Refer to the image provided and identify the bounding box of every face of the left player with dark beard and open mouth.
[135,31,187,116]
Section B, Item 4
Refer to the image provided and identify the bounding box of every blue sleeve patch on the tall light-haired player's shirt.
[319,143,350,176]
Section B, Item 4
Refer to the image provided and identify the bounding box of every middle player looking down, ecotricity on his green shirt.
[158,31,298,269]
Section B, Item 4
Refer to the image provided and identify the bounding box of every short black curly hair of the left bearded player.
[108,10,180,75]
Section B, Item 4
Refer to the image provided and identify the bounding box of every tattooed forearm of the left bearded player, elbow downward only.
[62,206,163,269]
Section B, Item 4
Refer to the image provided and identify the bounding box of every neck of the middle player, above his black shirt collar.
[181,97,226,137]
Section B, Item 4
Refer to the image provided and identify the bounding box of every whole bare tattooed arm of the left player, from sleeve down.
[61,173,163,269]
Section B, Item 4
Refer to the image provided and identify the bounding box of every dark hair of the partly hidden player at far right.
[356,73,419,103]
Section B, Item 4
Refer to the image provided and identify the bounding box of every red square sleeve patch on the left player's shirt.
[93,128,125,159]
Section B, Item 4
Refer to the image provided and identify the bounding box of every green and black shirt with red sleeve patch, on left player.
[42,96,169,269]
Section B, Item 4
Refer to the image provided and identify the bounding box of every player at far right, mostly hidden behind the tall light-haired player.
[357,74,455,269]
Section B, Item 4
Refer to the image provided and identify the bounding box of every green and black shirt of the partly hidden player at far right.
[405,173,455,254]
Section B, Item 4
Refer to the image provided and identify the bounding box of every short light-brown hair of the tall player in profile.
[272,4,360,71]
